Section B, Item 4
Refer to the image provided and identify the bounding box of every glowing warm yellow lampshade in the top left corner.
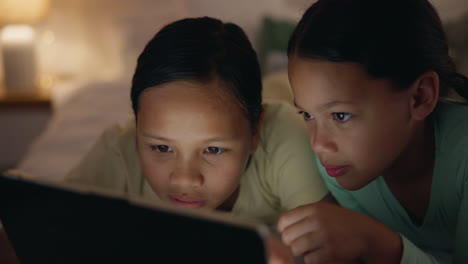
[0,0,50,25]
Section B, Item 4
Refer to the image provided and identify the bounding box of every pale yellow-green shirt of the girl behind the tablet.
[66,102,328,225]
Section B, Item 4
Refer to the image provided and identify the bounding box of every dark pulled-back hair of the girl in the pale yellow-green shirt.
[131,17,262,132]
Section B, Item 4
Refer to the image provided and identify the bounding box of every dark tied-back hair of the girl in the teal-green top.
[288,0,468,99]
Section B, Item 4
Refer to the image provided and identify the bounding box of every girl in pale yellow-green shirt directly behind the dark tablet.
[67,17,328,231]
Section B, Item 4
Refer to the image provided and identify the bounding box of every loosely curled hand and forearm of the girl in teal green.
[278,202,402,263]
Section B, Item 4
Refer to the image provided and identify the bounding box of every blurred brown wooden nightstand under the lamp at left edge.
[0,87,52,170]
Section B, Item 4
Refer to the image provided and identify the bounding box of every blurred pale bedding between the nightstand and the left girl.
[18,77,133,179]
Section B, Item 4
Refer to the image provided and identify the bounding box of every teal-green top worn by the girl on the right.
[318,103,468,263]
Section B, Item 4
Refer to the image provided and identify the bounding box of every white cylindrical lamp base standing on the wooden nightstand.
[1,25,37,93]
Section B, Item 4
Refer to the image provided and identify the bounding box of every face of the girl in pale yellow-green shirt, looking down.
[137,81,258,210]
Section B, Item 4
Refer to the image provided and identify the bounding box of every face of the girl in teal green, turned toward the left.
[289,57,413,190]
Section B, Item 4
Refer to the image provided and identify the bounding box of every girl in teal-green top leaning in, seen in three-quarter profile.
[278,0,468,263]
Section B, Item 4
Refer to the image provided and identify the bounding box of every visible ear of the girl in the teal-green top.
[410,71,439,120]
